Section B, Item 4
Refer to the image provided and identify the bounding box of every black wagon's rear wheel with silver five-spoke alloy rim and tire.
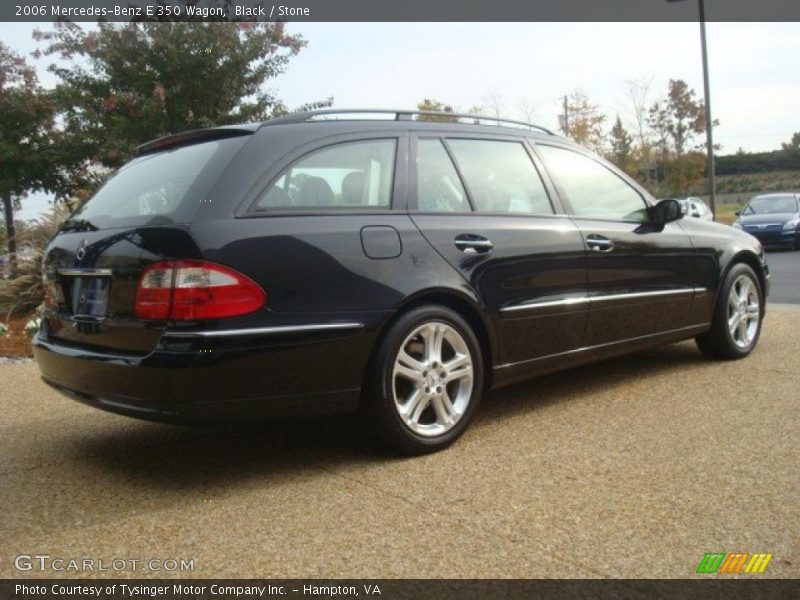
[362,305,484,454]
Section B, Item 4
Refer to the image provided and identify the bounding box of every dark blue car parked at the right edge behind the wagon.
[733,194,800,250]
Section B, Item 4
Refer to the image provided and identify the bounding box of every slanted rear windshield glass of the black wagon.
[71,136,249,229]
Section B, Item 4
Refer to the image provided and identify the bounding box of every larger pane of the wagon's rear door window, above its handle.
[447,139,553,215]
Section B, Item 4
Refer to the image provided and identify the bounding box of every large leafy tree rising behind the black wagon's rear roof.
[34,22,331,168]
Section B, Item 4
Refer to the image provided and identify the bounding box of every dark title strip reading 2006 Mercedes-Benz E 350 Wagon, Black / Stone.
[0,0,800,22]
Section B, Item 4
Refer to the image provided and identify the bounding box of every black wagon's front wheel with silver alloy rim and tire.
[695,263,764,360]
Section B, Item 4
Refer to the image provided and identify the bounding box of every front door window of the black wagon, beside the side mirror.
[537,145,647,222]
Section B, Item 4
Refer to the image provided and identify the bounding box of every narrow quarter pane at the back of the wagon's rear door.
[416,139,472,212]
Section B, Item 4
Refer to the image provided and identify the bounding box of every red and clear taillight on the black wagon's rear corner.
[134,260,267,321]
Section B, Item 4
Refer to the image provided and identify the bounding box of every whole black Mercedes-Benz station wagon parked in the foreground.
[34,110,768,452]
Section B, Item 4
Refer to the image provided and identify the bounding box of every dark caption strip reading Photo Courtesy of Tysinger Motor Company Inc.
[0,576,800,600]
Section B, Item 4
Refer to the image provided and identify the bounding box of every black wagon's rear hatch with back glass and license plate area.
[43,129,250,355]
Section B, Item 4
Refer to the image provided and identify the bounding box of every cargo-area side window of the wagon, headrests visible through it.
[255,139,395,211]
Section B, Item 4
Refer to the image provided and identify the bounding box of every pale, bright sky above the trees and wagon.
[0,23,800,218]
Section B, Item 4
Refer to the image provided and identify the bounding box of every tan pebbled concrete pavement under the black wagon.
[0,311,800,578]
